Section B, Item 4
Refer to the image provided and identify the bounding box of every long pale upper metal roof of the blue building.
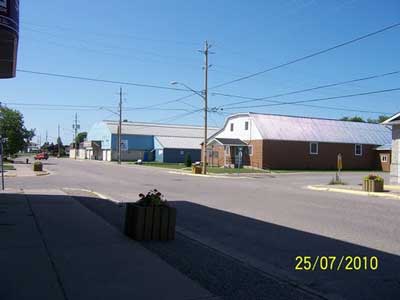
[104,121,218,138]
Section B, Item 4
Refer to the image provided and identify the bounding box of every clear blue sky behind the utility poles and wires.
[0,0,400,143]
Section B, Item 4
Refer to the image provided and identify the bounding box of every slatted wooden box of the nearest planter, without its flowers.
[125,203,176,241]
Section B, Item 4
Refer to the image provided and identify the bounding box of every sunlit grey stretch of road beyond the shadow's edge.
[6,159,400,253]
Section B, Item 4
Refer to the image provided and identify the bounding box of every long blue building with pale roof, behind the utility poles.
[83,121,218,163]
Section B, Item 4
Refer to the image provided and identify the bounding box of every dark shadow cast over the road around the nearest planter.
[72,193,400,300]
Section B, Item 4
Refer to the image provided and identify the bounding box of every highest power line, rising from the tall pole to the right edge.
[212,23,400,89]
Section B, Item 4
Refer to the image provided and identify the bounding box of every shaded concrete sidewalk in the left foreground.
[0,190,216,300]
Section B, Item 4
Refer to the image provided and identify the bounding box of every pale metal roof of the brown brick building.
[249,113,392,145]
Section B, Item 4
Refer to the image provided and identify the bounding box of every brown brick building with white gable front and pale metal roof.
[207,113,392,170]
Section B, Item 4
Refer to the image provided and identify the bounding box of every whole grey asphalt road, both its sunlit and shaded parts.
[6,159,400,299]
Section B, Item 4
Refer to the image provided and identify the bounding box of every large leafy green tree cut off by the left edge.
[0,107,35,155]
